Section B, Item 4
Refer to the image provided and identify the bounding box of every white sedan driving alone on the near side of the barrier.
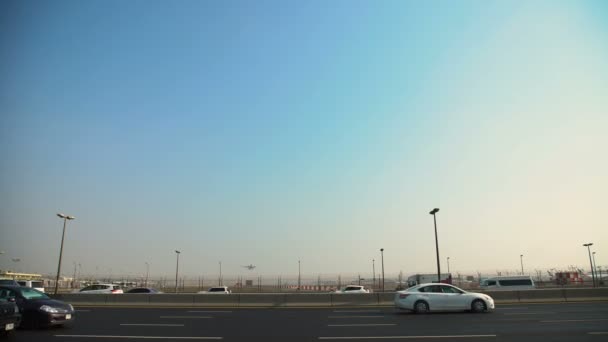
[395,283,494,313]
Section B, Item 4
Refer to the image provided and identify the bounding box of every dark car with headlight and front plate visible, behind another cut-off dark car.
[0,286,74,328]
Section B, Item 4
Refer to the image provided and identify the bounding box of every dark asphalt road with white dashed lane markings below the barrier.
[9,302,608,342]
